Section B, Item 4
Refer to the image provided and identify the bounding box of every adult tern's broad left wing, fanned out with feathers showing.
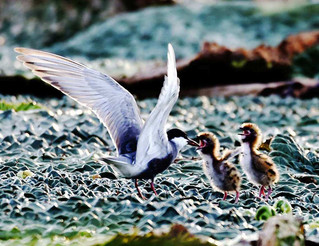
[15,48,143,154]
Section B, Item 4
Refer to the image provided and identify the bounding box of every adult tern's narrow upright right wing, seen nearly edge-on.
[136,44,180,165]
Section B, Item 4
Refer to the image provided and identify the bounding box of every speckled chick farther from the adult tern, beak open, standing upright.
[240,123,279,200]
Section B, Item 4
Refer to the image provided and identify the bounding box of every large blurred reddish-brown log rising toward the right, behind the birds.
[118,31,319,93]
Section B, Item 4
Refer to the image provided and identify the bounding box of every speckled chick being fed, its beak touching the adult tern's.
[197,132,241,203]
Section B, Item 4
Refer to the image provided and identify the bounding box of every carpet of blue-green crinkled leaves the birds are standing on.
[0,96,319,245]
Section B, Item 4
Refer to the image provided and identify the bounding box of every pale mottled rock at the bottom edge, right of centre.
[257,214,305,246]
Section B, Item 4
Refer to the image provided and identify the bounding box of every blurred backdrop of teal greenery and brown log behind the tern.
[0,0,319,98]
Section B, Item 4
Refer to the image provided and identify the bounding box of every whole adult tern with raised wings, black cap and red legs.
[15,45,200,198]
